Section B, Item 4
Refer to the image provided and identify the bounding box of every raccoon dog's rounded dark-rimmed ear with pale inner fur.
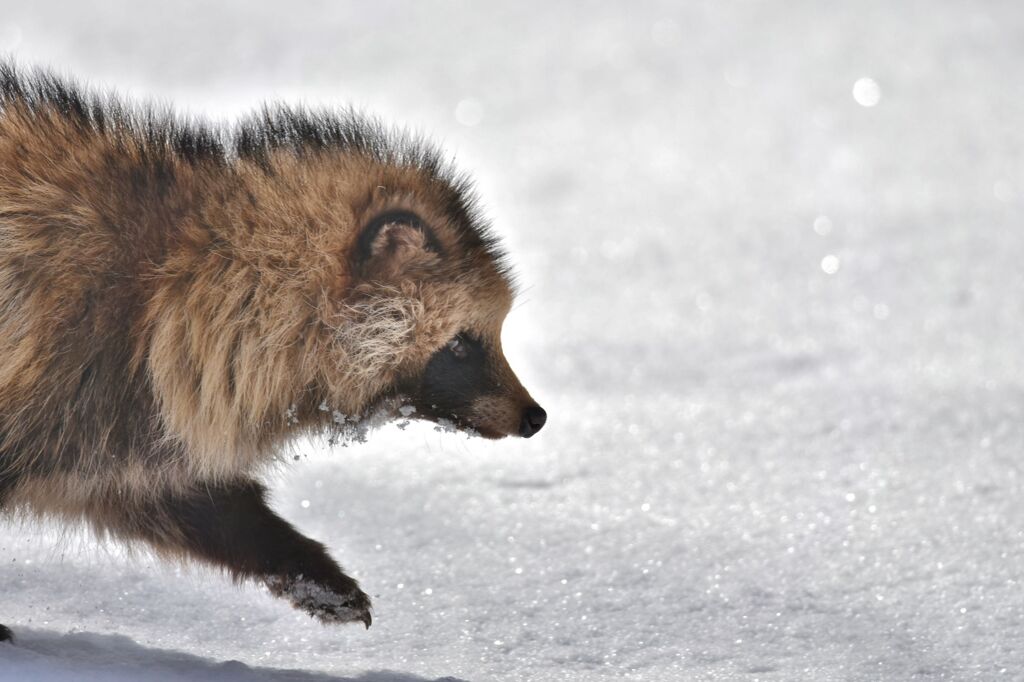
[356,211,441,279]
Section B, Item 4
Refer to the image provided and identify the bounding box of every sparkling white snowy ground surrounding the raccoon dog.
[0,0,1024,682]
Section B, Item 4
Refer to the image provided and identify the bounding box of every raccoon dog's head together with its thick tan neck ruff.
[133,106,547,462]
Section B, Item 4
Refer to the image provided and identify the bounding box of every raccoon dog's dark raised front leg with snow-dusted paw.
[136,480,371,628]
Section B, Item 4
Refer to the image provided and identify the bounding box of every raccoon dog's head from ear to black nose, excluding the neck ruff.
[327,160,547,438]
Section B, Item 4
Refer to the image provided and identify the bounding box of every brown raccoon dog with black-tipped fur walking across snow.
[0,62,546,639]
